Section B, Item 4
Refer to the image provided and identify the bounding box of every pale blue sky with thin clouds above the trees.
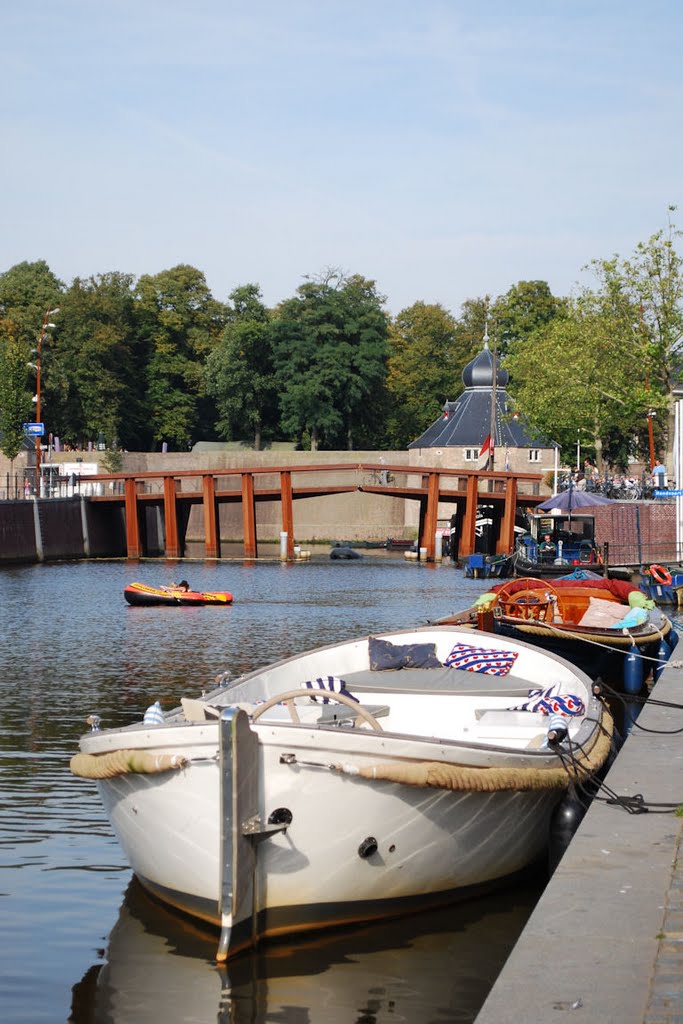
[0,0,683,315]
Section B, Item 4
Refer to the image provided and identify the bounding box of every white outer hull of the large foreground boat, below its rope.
[98,729,562,945]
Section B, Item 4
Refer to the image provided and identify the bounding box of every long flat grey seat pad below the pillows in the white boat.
[341,668,531,697]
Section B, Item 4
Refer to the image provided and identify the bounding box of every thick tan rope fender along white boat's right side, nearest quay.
[358,712,614,793]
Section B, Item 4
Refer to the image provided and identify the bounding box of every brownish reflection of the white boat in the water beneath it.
[69,881,538,1024]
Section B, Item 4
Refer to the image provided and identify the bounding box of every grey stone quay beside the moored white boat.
[475,658,683,1024]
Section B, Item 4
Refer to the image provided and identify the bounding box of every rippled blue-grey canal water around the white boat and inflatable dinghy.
[0,552,577,1024]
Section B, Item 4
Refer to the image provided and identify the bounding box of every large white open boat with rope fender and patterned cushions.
[72,626,611,959]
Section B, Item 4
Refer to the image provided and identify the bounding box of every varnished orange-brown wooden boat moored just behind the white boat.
[440,571,678,692]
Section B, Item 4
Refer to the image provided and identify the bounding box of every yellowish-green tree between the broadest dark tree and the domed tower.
[387,302,462,449]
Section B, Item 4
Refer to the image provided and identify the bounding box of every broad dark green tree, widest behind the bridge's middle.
[273,270,388,451]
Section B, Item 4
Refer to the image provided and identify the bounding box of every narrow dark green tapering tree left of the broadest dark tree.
[207,285,279,452]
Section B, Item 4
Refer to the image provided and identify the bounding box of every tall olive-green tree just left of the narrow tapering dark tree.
[137,265,225,447]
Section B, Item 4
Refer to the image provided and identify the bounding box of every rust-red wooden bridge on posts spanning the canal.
[85,463,542,561]
